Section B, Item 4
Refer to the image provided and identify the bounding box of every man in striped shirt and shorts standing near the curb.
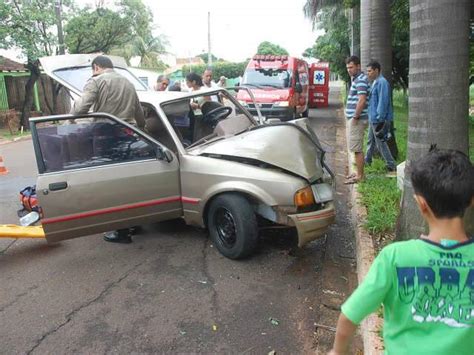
[344,56,369,184]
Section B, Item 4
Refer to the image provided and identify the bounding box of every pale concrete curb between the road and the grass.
[346,121,384,355]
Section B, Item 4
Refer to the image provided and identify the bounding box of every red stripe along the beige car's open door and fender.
[41,196,199,224]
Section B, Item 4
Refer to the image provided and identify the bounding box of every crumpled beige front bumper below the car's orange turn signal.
[288,201,336,247]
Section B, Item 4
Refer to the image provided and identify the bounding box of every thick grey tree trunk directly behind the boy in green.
[397,0,472,240]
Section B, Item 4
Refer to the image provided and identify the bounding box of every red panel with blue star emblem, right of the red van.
[309,62,329,108]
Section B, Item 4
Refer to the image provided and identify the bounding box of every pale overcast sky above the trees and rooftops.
[0,0,317,61]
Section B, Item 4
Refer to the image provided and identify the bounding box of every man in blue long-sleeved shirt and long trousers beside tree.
[365,60,396,172]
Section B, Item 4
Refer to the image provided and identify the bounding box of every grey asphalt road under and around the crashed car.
[0,82,360,354]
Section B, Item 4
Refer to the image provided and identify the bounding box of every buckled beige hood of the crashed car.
[189,124,323,182]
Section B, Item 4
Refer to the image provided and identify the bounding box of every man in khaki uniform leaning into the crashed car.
[71,55,145,243]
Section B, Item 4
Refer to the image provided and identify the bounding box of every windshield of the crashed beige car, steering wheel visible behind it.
[156,90,256,149]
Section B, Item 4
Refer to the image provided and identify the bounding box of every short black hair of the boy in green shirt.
[411,148,474,218]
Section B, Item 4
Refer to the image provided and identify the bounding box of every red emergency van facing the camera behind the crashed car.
[237,54,309,120]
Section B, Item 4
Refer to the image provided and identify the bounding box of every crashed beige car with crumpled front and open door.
[30,55,335,259]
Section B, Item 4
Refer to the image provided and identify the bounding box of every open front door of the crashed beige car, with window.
[30,113,182,242]
